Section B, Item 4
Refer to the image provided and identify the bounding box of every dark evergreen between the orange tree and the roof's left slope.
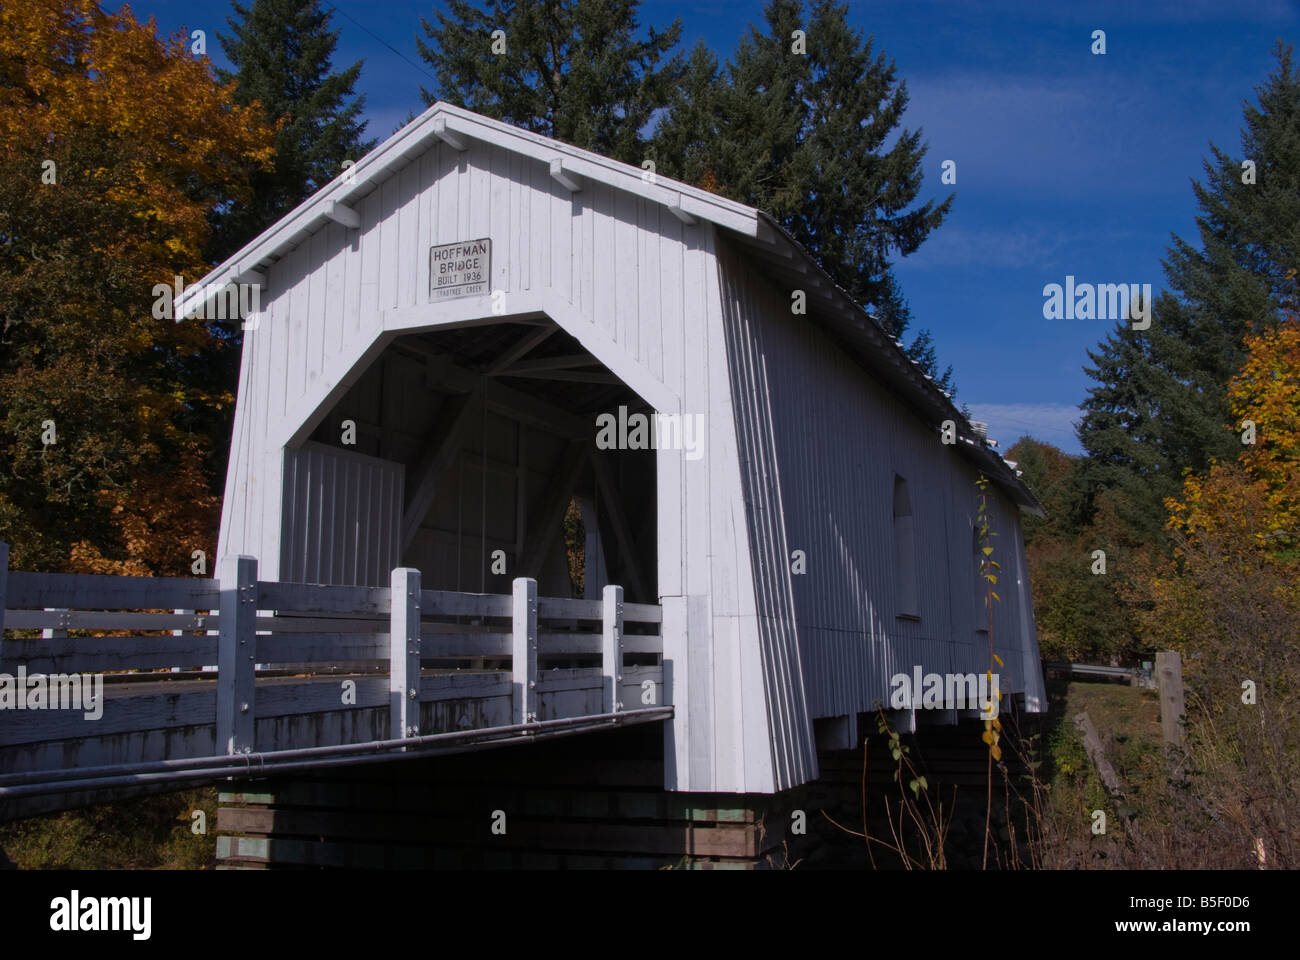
[209,0,374,261]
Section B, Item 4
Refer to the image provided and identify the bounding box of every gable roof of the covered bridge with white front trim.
[185,100,1044,516]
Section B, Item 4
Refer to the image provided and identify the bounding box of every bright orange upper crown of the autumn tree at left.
[0,0,273,282]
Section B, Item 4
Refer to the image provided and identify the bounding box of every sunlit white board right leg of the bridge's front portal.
[657,225,800,792]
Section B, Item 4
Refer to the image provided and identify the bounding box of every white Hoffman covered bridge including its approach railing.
[0,103,1043,822]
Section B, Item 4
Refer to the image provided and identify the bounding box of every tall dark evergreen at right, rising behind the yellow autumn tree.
[1079,43,1300,542]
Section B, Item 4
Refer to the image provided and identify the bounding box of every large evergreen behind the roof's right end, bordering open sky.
[655,0,953,390]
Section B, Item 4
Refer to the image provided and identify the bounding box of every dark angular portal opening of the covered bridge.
[281,317,658,604]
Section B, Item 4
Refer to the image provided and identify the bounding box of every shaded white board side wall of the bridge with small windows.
[720,239,1041,717]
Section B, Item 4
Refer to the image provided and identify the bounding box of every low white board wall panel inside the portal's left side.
[280,442,403,587]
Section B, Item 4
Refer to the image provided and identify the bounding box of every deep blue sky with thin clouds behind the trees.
[109,0,1300,453]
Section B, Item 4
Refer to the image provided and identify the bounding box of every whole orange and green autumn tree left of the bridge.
[0,0,273,574]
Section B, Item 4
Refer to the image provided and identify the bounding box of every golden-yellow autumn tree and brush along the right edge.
[1128,271,1300,868]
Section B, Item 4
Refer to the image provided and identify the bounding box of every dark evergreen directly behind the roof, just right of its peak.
[416,0,683,165]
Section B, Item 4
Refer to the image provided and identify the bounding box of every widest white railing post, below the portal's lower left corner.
[217,557,257,753]
